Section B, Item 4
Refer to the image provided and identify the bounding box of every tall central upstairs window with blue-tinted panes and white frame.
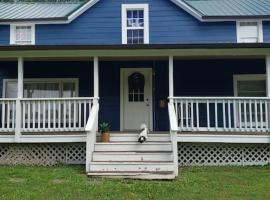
[122,4,149,44]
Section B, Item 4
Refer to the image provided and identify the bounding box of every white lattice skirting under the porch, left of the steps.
[0,143,85,165]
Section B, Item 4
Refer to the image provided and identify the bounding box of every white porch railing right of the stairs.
[170,97,270,132]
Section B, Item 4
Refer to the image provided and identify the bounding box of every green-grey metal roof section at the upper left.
[0,0,98,23]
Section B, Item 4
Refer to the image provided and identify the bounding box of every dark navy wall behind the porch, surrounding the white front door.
[0,59,265,131]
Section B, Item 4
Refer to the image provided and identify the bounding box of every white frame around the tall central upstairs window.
[122,4,149,44]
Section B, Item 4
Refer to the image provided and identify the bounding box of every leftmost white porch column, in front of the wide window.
[15,57,24,142]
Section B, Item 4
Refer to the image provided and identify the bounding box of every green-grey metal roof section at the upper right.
[172,0,270,21]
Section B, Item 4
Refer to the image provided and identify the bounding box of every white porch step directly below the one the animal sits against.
[94,142,172,152]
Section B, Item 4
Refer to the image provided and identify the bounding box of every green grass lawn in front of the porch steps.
[0,166,270,200]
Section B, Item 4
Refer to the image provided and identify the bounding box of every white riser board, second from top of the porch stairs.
[95,144,172,152]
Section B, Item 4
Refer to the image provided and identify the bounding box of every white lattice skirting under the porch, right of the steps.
[178,143,270,166]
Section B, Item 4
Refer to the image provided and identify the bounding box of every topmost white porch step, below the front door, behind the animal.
[98,133,171,142]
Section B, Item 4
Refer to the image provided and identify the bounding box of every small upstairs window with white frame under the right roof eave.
[236,21,263,43]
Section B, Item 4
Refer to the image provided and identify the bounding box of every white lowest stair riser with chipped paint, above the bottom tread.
[90,162,174,173]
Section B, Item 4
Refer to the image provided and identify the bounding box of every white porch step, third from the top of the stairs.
[93,152,173,162]
